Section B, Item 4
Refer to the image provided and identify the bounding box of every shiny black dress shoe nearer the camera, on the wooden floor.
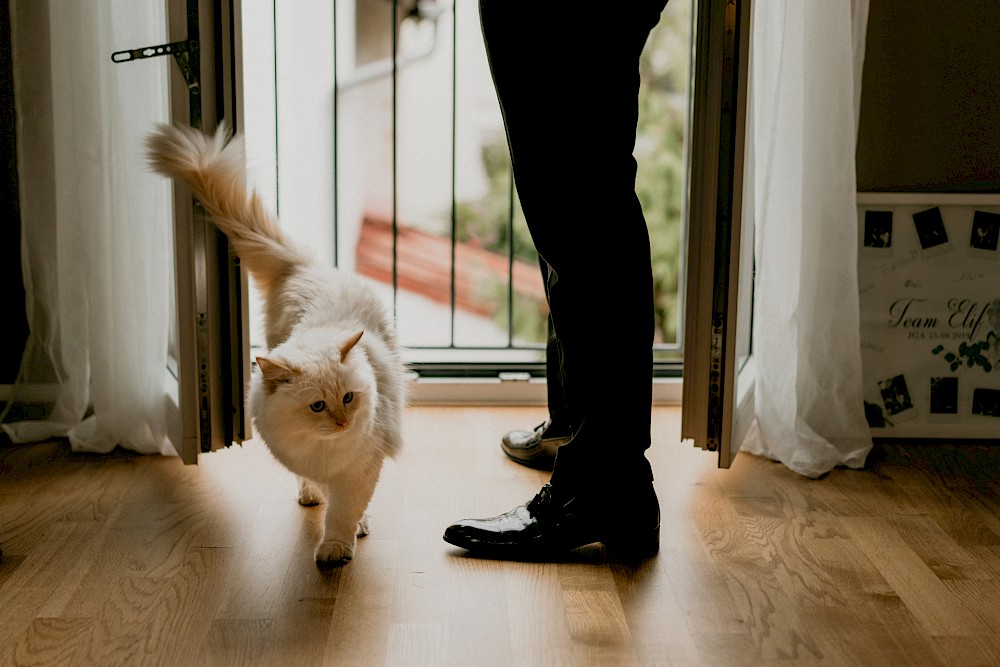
[444,484,660,562]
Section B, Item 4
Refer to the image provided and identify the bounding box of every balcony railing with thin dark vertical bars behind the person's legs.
[262,0,691,384]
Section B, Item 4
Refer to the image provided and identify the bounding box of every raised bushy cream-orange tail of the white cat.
[146,124,306,292]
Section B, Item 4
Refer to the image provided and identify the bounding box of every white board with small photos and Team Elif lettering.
[858,193,1000,440]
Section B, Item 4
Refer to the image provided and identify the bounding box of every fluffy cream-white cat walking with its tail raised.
[147,125,405,564]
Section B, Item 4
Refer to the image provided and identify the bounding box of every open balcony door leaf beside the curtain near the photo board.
[681,0,754,468]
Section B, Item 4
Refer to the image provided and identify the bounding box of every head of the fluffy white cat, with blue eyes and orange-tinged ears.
[255,333,375,441]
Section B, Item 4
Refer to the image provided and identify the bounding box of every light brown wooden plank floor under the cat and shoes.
[0,408,1000,667]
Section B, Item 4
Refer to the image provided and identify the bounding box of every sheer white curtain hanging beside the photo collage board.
[742,0,872,477]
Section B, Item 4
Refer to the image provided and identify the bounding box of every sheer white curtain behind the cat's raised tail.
[3,0,173,454]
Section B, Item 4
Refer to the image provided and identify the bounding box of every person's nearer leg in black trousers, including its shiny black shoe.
[445,0,665,560]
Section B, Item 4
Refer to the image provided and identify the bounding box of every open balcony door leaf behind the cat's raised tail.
[167,0,250,463]
